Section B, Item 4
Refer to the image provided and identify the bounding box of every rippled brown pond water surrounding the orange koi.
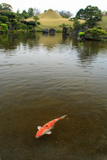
[0,33,107,160]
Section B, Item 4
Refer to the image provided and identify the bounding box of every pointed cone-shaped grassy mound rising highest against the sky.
[38,9,62,19]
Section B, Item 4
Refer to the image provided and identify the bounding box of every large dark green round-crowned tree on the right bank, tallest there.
[76,5,102,28]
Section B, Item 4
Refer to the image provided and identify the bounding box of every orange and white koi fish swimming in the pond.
[35,115,67,138]
